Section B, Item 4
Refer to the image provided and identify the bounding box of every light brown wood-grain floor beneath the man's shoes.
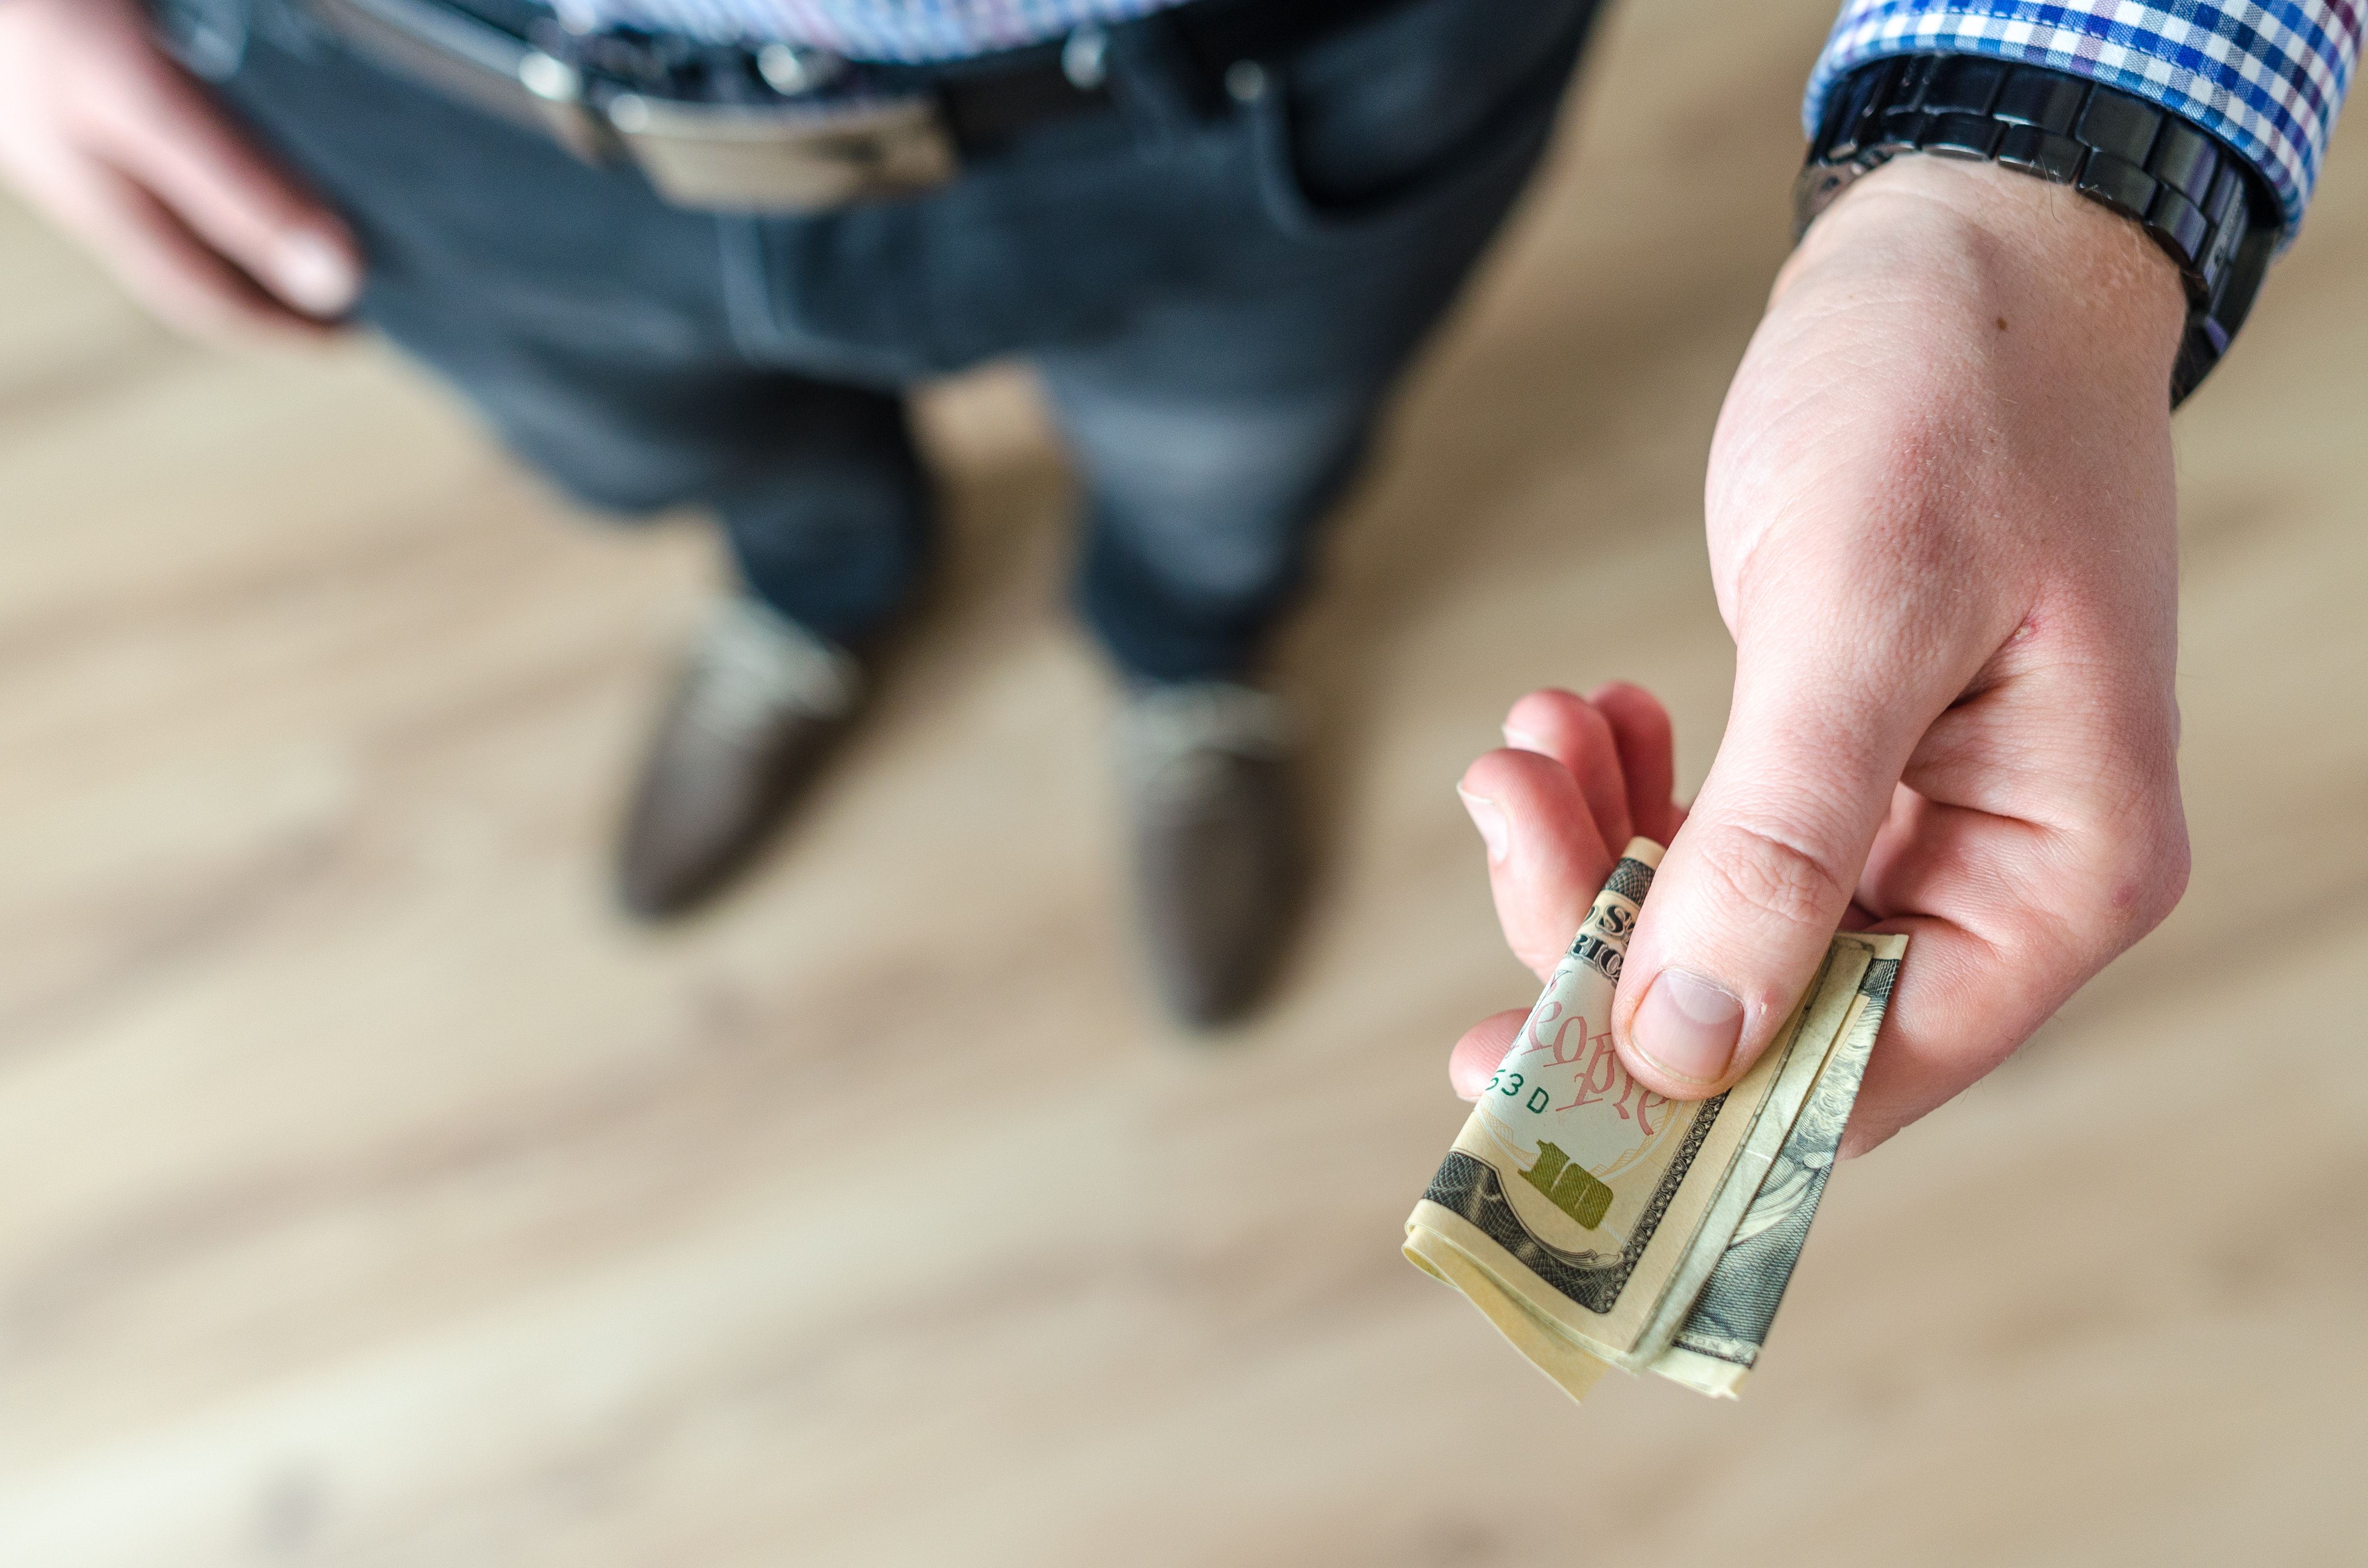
[0,0,2368,1568]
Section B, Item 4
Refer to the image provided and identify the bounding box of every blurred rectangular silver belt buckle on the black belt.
[604,92,959,213]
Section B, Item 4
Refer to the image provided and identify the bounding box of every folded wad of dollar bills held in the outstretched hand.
[1406,838,1909,1400]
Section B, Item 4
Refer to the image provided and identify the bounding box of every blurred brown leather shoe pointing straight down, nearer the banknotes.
[1118,682,1300,1028]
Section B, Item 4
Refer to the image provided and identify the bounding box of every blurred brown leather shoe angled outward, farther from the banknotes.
[618,599,862,919]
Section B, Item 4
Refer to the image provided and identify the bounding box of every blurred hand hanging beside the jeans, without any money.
[0,0,362,336]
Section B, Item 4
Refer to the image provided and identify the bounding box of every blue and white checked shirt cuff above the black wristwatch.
[1802,0,2368,237]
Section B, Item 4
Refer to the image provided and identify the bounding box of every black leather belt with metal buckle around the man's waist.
[301,0,1406,211]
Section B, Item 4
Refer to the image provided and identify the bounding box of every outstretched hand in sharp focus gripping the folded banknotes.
[1452,156,2188,1153]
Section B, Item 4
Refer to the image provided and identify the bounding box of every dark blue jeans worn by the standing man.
[182,0,1594,680]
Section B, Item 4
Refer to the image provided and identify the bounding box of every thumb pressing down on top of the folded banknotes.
[1613,661,1930,1099]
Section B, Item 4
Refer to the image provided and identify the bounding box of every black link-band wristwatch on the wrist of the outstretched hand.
[1792,54,2281,407]
